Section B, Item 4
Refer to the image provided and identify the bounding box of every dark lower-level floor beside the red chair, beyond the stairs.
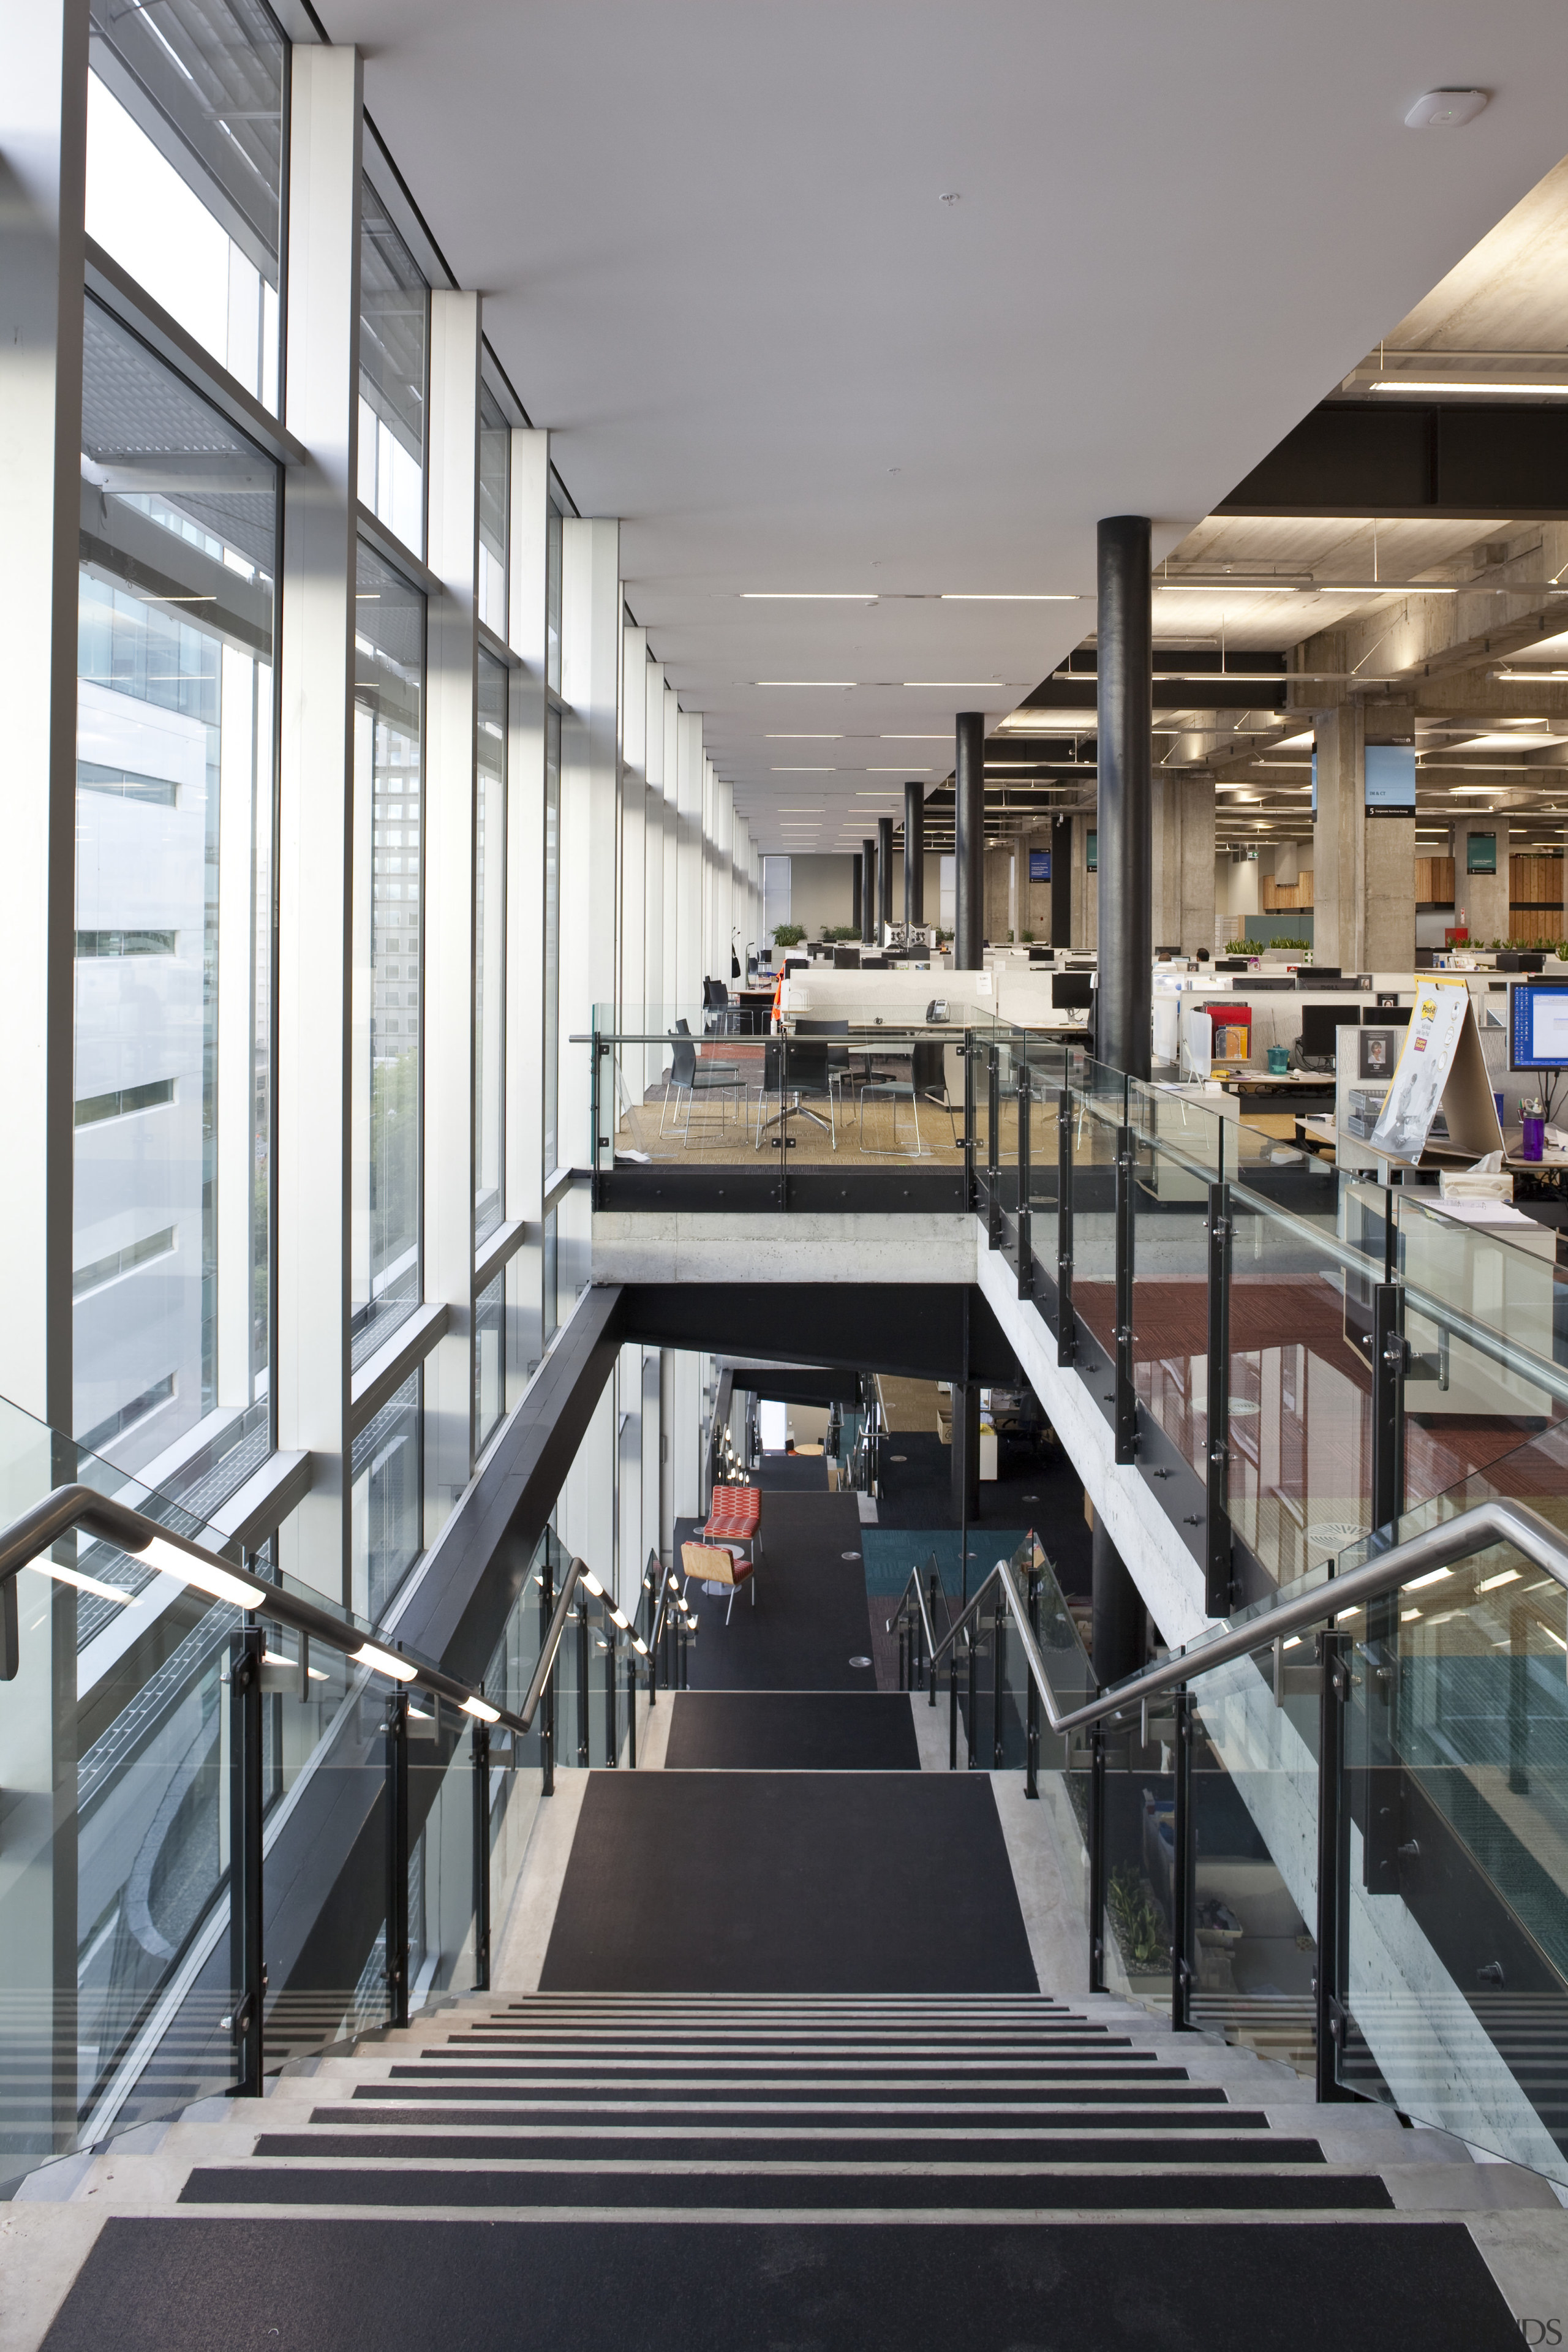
[675,1493,877,1691]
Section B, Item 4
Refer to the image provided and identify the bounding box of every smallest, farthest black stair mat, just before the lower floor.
[665,1691,919,1771]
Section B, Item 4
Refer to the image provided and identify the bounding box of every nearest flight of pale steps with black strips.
[51,1992,1549,2223]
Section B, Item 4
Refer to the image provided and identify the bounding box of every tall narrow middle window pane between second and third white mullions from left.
[353,546,426,1366]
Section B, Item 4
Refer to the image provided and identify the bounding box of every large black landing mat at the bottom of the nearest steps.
[541,1771,1039,1992]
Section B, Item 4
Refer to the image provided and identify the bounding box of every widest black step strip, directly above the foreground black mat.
[179,2166,1394,2220]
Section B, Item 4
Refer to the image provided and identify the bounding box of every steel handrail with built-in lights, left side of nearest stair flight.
[0,1487,529,1731]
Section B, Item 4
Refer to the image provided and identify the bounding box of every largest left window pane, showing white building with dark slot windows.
[73,301,277,1510]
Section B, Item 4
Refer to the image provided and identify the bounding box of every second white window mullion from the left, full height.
[277,45,362,1604]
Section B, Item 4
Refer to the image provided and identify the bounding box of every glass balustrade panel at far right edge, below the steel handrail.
[1338,1545,1568,2183]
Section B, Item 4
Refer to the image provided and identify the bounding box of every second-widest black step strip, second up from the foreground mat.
[252,2131,1324,2171]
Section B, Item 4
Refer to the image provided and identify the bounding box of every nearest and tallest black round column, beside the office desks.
[1096,515,1154,1080]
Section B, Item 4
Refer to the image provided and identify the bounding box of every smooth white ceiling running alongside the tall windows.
[322,0,1568,846]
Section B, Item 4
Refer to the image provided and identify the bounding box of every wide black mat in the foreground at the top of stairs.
[42,2213,1518,2352]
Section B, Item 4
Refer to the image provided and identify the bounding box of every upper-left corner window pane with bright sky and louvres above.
[87,0,289,412]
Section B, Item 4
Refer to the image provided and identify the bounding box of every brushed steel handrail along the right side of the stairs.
[889,1496,1568,1731]
